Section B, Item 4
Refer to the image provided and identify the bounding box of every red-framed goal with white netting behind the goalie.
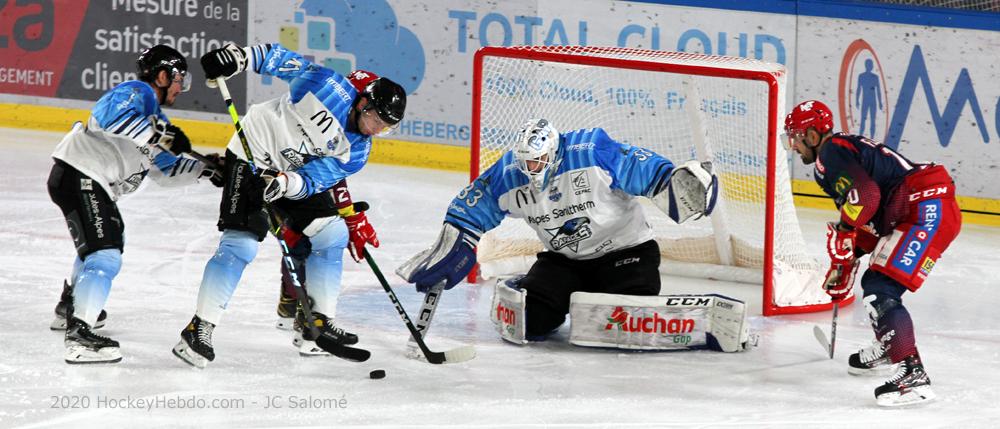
[470,46,830,315]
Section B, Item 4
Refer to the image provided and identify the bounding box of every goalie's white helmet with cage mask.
[514,119,561,191]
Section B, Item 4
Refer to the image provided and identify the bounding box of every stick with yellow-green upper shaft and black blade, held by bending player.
[213,77,371,362]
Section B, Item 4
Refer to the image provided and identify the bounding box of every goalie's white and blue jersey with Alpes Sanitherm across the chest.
[445,128,674,259]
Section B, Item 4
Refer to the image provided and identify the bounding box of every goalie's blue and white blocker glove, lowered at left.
[396,222,479,293]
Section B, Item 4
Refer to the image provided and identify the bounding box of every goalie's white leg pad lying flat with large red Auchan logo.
[569,292,750,352]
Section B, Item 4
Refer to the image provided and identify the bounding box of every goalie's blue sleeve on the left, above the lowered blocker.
[444,160,507,238]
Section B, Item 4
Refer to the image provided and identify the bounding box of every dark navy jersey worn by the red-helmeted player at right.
[813,133,922,235]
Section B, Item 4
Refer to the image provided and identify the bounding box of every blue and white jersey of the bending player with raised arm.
[229,44,371,199]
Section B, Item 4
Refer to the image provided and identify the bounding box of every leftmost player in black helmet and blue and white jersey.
[48,45,221,363]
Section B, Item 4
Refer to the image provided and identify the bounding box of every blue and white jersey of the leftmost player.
[52,80,205,200]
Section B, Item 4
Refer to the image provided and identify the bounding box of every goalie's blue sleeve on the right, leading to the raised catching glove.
[594,129,674,197]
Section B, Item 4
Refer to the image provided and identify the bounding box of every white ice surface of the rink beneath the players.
[0,124,1000,428]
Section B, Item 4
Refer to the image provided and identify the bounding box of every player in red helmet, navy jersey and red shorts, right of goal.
[785,100,962,406]
